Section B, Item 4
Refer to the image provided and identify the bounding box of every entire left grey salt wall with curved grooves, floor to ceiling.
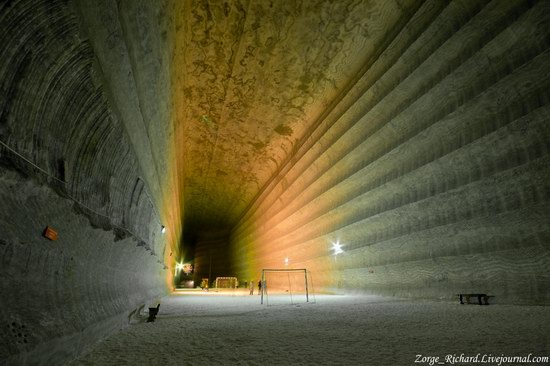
[0,0,172,365]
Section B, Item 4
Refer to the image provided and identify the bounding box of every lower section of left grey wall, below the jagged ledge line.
[0,170,166,365]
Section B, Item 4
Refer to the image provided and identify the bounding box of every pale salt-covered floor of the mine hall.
[71,292,550,365]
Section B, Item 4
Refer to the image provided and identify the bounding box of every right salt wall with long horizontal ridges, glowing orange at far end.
[231,1,550,304]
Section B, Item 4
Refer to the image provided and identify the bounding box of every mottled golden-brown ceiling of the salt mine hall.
[170,0,418,231]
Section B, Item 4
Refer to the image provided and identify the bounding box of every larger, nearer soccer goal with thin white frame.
[261,268,315,305]
